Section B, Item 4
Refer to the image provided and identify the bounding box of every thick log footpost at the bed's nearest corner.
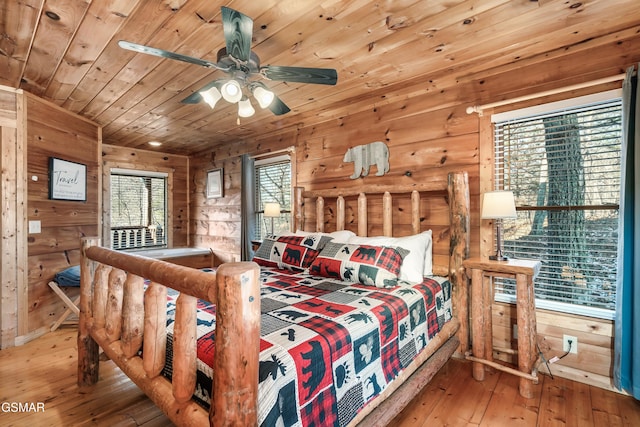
[209,262,260,426]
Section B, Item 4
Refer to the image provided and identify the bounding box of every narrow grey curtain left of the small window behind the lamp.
[240,154,256,261]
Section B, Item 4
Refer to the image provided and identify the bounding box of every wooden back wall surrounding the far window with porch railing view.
[102,144,191,248]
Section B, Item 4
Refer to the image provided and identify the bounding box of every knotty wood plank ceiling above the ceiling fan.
[0,0,640,154]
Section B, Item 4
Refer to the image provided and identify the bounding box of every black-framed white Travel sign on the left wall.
[49,157,87,202]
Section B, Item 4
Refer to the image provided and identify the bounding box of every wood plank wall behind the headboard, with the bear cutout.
[191,37,640,388]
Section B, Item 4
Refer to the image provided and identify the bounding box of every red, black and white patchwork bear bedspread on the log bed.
[165,267,451,426]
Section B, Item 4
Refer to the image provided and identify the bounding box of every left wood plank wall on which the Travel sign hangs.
[24,94,101,340]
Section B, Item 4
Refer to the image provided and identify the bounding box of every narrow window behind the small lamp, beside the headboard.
[255,155,291,240]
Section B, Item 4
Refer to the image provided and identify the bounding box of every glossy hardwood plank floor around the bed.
[0,327,640,427]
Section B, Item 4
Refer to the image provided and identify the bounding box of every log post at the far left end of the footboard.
[78,237,100,387]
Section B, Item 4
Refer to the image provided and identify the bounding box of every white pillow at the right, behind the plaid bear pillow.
[347,230,433,283]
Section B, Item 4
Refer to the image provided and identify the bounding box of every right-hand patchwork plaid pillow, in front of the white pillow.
[309,242,409,288]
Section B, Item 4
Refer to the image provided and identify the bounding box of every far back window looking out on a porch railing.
[110,169,167,249]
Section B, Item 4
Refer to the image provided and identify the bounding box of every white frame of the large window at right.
[487,89,622,320]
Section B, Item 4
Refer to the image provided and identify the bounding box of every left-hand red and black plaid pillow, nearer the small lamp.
[253,234,331,271]
